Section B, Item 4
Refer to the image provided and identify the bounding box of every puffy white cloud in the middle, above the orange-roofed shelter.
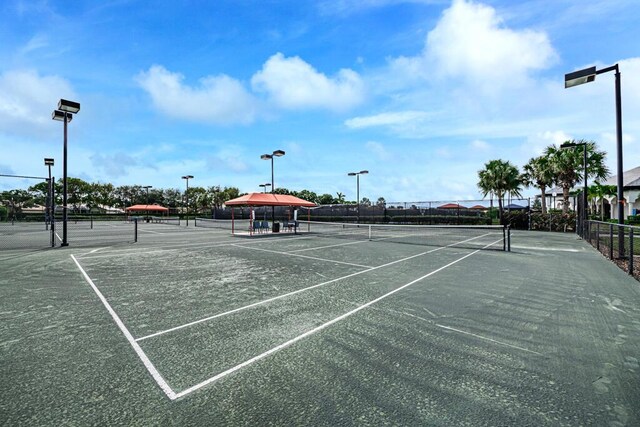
[251,53,364,111]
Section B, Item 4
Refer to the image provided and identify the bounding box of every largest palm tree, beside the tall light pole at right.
[545,139,609,214]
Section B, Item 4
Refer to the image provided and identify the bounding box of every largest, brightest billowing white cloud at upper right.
[392,0,557,87]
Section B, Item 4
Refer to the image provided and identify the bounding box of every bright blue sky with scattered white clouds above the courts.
[0,0,640,202]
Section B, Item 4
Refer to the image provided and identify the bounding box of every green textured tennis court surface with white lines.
[0,224,640,426]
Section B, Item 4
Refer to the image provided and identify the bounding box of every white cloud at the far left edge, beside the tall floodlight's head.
[0,70,77,133]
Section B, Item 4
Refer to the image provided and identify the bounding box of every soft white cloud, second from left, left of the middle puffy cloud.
[136,65,257,124]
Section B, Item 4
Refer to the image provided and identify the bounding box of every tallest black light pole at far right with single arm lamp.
[564,64,624,257]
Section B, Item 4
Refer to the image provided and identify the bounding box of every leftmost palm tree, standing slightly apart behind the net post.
[478,160,522,223]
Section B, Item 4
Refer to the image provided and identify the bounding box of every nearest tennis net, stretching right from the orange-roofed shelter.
[300,221,511,251]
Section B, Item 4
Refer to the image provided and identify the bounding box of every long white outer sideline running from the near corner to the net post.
[176,239,502,399]
